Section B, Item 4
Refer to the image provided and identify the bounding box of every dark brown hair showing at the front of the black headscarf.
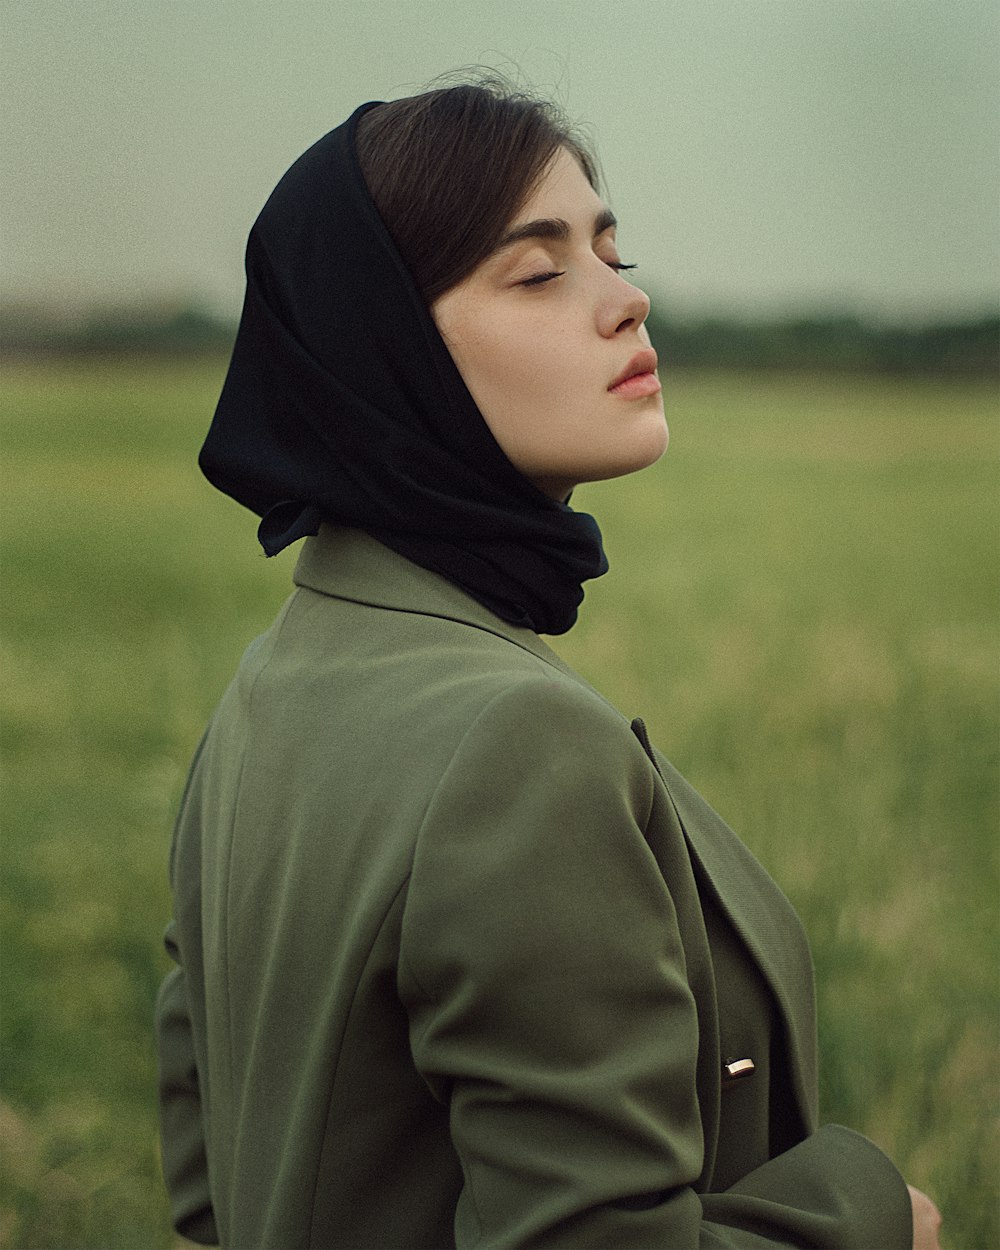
[356,78,598,305]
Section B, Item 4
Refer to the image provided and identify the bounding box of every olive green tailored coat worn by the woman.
[158,526,911,1250]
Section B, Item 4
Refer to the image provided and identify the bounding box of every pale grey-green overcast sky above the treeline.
[0,0,1000,319]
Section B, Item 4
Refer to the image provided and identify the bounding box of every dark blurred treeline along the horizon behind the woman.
[0,303,1000,379]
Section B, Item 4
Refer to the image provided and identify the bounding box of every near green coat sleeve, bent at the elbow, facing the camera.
[400,678,910,1250]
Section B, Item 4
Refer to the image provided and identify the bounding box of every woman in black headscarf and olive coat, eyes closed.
[158,85,936,1250]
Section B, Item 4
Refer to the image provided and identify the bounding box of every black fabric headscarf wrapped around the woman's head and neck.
[199,103,608,634]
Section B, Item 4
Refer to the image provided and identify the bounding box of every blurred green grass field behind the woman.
[0,363,1000,1250]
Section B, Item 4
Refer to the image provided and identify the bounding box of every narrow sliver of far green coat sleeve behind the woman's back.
[156,925,219,1245]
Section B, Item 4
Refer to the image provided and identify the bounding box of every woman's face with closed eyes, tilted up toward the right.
[431,149,668,500]
